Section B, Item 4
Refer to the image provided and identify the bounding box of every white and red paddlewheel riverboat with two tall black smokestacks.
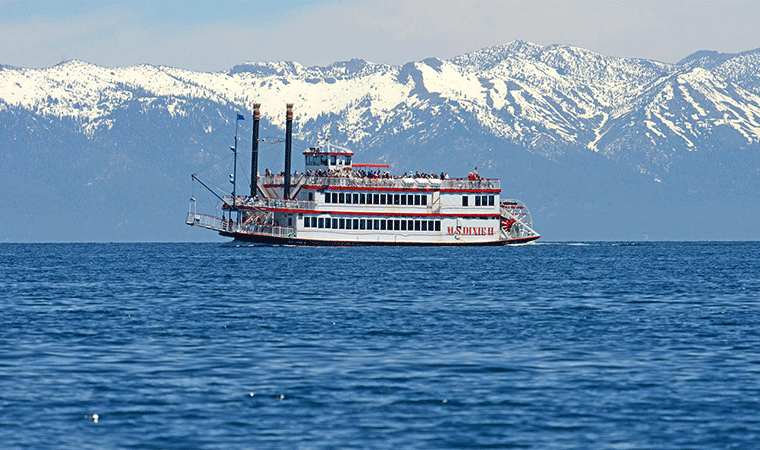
[186,104,541,246]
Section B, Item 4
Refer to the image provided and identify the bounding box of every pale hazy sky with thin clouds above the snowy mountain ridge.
[0,0,760,71]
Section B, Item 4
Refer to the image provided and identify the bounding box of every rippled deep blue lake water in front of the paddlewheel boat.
[0,243,760,450]
